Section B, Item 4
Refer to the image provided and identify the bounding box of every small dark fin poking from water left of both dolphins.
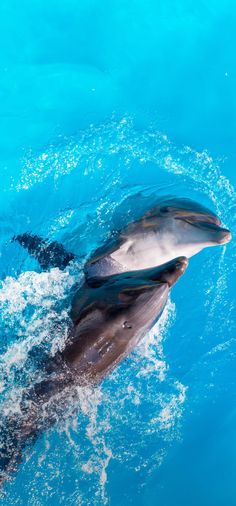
[13,233,75,270]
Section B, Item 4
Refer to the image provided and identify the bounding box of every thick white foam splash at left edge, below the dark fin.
[0,269,78,409]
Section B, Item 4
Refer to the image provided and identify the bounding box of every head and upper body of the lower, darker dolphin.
[67,257,187,383]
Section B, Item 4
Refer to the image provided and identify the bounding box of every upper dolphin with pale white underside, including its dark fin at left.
[14,196,231,280]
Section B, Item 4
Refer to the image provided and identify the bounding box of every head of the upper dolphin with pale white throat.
[139,197,231,262]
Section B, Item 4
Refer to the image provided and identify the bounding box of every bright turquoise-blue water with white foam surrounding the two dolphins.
[0,0,236,506]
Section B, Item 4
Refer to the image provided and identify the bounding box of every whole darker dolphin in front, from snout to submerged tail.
[0,257,188,483]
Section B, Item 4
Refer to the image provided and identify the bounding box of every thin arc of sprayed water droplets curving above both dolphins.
[14,117,236,210]
